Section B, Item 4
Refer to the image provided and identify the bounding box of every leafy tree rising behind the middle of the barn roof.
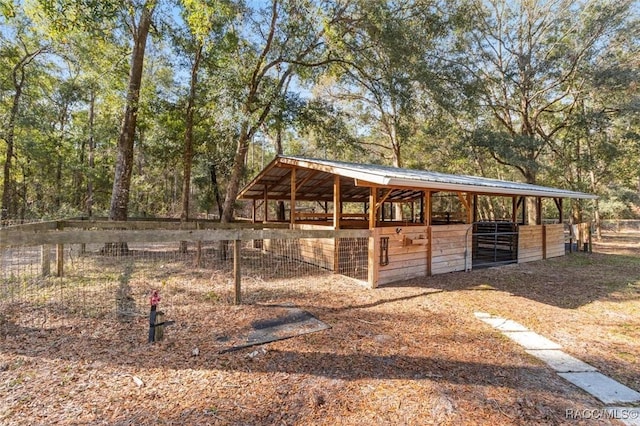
[325,0,462,167]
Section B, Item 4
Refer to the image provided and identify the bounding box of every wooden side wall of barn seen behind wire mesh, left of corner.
[263,224,335,271]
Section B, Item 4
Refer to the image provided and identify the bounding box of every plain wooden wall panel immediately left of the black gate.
[431,224,473,275]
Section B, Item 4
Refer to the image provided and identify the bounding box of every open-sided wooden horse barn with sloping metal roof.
[238,156,596,288]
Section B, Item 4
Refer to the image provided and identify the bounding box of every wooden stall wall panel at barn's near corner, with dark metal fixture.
[376,226,429,286]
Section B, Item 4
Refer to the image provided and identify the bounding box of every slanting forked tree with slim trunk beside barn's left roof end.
[222,0,345,222]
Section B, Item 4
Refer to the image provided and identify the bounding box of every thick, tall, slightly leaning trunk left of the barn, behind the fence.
[109,1,155,221]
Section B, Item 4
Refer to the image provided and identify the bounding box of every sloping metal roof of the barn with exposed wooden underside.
[238,156,597,202]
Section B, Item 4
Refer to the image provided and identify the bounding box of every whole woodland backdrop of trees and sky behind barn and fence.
[0,0,640,225]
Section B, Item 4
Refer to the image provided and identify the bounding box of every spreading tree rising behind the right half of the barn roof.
[468,0,631,222]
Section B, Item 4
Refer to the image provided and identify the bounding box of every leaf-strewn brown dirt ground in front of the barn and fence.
[0,232,640,425]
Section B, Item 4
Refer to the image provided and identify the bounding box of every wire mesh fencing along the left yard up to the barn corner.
[0,231,369,327]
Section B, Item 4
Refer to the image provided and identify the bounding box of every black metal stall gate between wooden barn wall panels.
[472,222,518,269]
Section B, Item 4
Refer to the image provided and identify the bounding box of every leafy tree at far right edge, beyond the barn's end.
[551,10,640,226]
